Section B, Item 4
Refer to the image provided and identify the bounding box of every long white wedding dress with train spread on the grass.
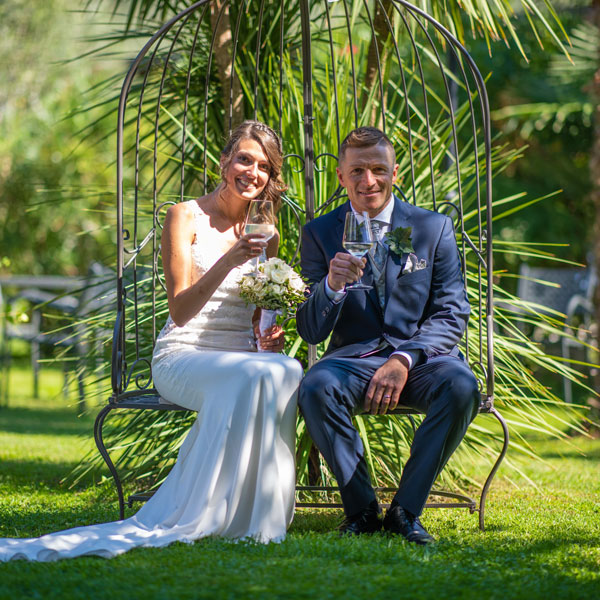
[0,200,302,561]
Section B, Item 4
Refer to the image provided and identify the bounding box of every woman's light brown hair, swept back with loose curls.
[221,121,288,213]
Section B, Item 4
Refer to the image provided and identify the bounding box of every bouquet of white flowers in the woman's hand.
[239,258,306,351]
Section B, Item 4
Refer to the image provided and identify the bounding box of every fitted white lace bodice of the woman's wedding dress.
[153,200,256,363]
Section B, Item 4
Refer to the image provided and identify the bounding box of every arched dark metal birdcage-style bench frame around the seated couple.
[94,0,508,529]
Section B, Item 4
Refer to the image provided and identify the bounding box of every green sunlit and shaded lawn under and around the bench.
[0,369,600,600]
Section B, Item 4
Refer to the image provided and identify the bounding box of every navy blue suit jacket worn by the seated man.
[296,197,470,364]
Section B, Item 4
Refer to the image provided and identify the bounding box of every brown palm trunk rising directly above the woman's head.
[210,0,244,135]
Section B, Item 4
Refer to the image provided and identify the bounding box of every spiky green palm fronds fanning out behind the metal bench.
[65,0,586,496]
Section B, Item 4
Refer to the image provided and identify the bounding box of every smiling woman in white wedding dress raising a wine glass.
[0,121,302,561]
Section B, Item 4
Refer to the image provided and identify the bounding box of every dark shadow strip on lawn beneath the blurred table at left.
[0,406,93,436]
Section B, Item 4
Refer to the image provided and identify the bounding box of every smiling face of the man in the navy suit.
[337,143,398,218]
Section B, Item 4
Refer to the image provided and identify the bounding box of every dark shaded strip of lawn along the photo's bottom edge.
[3,537,597,600]
